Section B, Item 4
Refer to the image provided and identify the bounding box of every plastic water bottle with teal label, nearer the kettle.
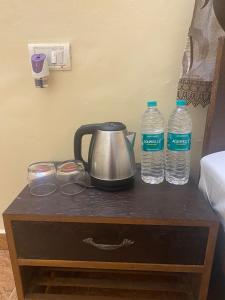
[141,101,164,184]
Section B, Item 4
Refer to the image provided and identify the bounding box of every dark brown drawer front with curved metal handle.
[12,221,208,265]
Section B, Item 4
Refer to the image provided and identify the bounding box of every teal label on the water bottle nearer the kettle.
[142,133,164,152]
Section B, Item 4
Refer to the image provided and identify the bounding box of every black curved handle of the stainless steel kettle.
[74,124,101,170]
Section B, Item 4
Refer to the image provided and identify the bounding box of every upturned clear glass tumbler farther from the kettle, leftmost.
[28,162,57,197]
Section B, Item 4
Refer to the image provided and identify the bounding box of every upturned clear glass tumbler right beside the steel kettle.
[56,161,86,196]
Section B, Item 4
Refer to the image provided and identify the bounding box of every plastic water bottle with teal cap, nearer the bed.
[166,100,192,184]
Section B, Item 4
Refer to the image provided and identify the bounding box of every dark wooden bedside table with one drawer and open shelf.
[4,171,218,300]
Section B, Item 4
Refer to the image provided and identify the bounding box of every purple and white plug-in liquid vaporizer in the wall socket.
[31,53,49,88]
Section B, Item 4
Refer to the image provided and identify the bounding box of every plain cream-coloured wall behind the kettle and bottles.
[0,0,206,228]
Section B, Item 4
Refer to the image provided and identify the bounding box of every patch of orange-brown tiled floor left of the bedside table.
[0,250,17,300]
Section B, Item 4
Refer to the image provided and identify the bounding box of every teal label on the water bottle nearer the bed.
[167,132,191,151]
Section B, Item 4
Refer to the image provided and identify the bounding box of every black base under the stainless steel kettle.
[91,177,134,192]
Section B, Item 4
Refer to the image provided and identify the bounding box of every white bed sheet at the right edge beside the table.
[199,151,225,230]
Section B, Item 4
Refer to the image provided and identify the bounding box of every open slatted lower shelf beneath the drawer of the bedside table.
[21,267,201,300]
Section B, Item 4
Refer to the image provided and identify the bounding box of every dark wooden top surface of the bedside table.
[4,171,217,223]
